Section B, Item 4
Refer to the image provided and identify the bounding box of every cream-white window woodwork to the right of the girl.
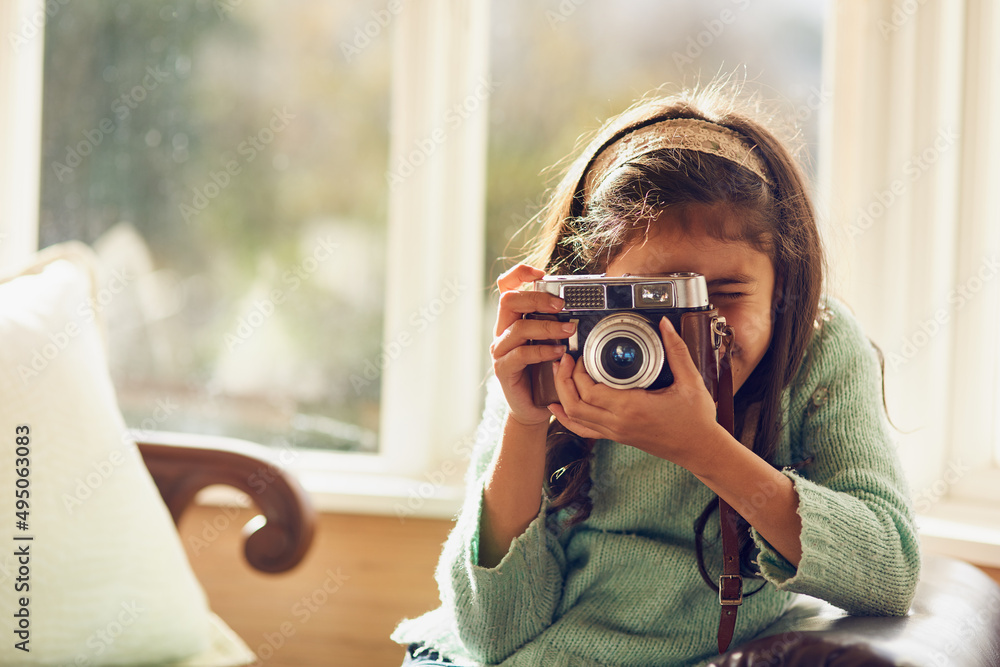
[822,0,1000,548]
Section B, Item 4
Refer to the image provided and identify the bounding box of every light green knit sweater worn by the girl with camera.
[392,301,919,667]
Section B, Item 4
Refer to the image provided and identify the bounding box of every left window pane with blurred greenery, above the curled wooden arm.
[39,0,391,452]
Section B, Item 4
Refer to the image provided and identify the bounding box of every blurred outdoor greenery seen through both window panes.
[39,0,828,460]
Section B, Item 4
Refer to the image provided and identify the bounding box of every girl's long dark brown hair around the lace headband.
[526,88,824,585]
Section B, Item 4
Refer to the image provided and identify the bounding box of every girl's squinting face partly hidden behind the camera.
[607,205,775,392]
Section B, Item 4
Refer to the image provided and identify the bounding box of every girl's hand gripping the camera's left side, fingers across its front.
[490,264,576,426]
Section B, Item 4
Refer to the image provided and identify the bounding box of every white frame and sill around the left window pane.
[0,0,493,519]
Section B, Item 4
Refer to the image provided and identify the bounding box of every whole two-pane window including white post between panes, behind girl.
[5,0,829,513]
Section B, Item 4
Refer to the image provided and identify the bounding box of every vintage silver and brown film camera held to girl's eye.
[524,273,725,406]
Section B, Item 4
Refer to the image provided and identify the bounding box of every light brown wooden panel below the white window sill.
[180,507,451,667]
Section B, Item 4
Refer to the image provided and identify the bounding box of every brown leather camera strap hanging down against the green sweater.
[717,327,743,653]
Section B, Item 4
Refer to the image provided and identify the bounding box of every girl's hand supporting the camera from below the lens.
[549,318,735,474]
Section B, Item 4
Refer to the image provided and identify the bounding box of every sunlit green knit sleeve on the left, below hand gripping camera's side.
[436,381,566,664]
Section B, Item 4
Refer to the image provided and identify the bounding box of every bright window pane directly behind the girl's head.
[486,0,830,272]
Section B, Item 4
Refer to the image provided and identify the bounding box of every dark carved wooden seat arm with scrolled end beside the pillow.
[133,431,316,573]
